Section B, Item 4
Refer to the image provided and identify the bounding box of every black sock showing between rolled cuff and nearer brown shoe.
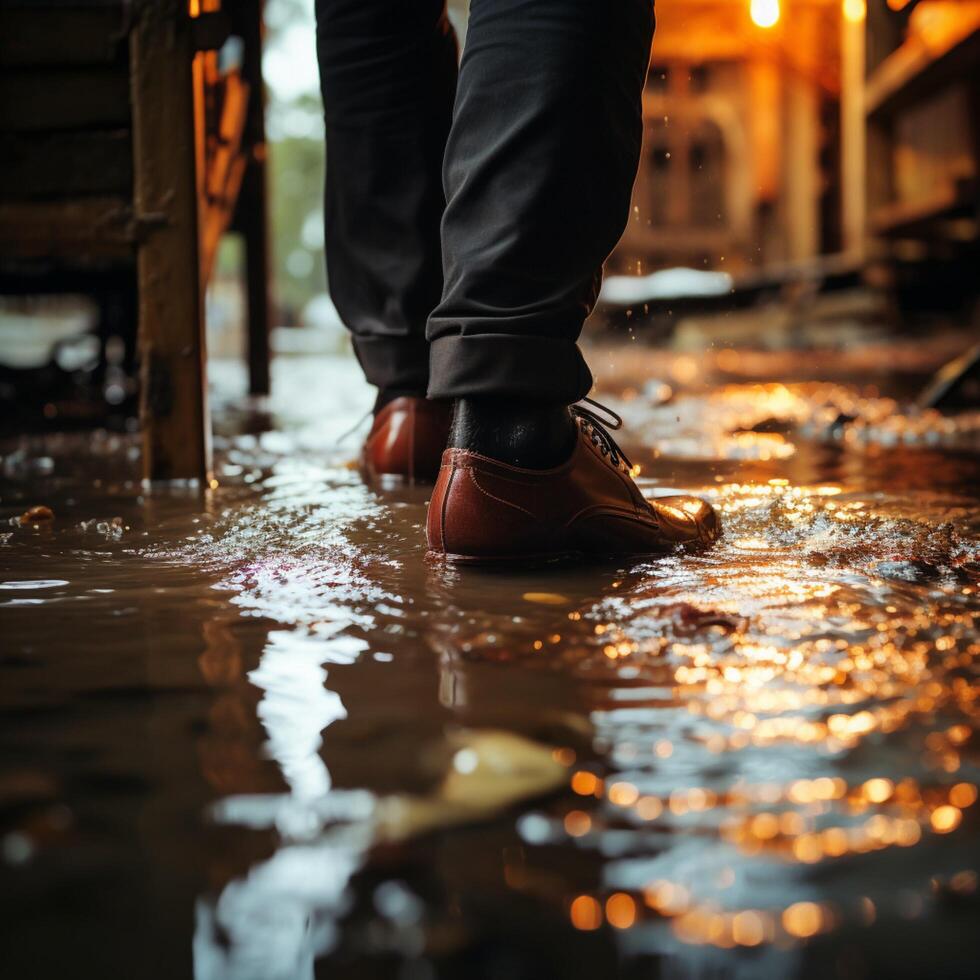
[449,398,577,469]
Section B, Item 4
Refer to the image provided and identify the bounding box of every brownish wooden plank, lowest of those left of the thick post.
[0,197,139,262]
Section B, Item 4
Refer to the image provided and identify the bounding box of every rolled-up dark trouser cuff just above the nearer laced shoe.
[429,334,592,405]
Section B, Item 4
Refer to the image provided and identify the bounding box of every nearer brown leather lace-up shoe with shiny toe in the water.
[427,400,720,564]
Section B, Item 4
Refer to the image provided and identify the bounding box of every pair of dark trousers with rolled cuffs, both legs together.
[316,0,654,404]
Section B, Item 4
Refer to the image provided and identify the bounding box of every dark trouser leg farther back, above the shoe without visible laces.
[316,0,456,408]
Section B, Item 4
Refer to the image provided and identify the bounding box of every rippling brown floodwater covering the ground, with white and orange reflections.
[0,340,980,980]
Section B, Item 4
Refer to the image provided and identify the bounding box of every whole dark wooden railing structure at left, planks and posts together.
[0,0,269,480]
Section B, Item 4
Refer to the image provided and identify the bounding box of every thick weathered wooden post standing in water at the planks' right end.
[130,0,211,480]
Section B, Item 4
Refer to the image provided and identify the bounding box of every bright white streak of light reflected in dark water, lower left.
[194,628,371,980]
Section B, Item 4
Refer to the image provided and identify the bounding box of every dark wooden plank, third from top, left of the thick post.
[0,129,133,200]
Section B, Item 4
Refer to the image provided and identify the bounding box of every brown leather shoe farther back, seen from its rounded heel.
[361,395,452,483]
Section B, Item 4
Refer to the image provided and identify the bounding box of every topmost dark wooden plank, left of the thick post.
[0,8,126,67]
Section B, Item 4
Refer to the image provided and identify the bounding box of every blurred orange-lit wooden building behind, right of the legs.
[615,0,980,294]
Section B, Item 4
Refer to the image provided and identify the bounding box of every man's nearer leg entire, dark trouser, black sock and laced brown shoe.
[418,0,718,567]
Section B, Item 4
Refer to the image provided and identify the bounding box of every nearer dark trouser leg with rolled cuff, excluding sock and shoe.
[428,0,654,432]
